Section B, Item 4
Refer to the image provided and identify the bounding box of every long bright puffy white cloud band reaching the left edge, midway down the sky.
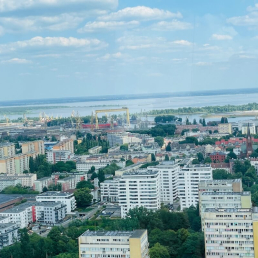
[0,37,107,53]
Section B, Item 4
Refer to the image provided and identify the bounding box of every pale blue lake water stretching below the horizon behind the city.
[0,93,258,122]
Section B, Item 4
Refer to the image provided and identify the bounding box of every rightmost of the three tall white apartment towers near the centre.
[178,164,212,210]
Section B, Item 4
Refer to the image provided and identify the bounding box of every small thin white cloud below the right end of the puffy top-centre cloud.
[152,20,192,31]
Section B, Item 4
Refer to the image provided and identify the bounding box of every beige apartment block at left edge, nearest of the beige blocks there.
[0,152,36,175]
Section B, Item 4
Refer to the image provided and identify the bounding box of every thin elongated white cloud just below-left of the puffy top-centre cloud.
[78,21,140,33]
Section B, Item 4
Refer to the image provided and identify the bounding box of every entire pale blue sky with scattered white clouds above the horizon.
[0,0,258,100]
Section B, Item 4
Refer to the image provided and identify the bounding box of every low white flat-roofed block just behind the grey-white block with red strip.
[36,191,76,213]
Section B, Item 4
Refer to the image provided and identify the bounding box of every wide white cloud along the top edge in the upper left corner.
[0,0,118,12]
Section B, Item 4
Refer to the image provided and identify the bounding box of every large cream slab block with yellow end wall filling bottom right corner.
[203,207,258,258]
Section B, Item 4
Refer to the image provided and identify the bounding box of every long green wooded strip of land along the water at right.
[143,103,258,115]
